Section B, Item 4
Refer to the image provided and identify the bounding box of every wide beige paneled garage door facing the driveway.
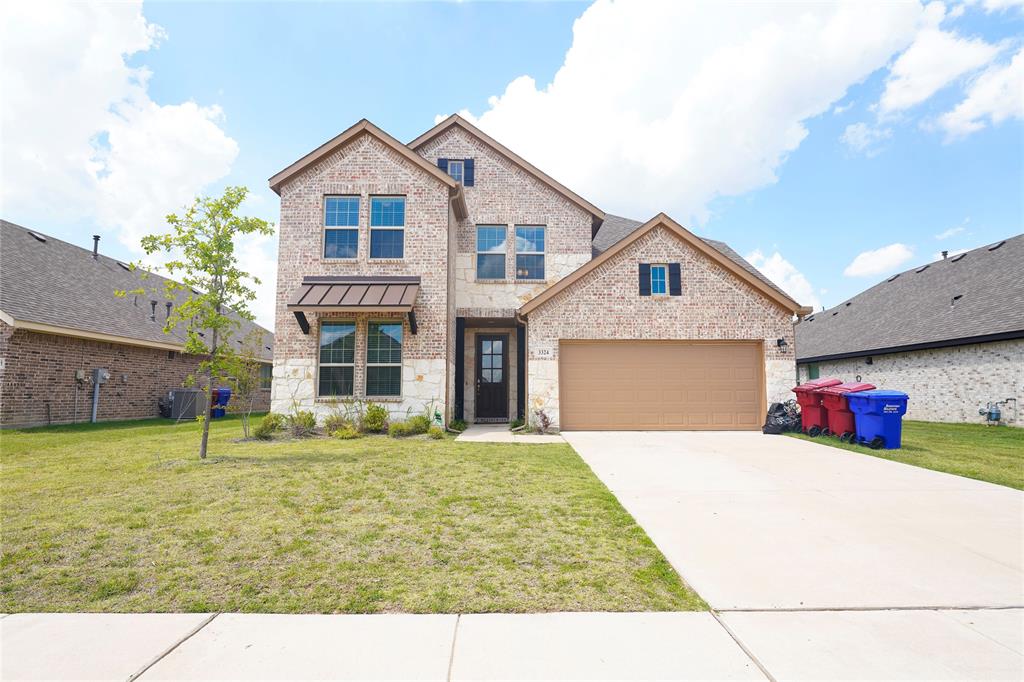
[558,341,764,430]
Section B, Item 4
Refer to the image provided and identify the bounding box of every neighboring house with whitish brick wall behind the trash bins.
[796,235,1024,426]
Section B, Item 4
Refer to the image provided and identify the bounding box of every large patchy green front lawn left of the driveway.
[0,419,706,613]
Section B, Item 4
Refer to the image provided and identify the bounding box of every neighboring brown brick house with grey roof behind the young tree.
[0,220,273,427]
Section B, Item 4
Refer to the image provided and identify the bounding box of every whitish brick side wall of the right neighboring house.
[800,339,1024,426]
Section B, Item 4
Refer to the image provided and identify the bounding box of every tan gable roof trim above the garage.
[519,213,807,315]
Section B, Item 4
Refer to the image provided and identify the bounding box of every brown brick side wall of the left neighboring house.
[0,323,269,427]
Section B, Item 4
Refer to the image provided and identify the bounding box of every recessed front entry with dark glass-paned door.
[454,317,526,424]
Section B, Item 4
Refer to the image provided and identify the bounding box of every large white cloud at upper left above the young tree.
[0,2,239,253]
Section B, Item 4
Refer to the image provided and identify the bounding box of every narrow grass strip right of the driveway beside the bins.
[788,421,1024,489]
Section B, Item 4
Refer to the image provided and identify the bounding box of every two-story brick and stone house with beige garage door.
[270,116,806,429]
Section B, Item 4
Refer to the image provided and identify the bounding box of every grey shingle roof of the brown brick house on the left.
[0,220,273,360]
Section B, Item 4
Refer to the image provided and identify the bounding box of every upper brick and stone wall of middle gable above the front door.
[417,126,591,316]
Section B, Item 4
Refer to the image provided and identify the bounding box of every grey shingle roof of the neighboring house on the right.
[797,235,1024,363]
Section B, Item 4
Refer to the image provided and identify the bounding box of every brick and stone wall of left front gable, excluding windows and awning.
[271,134,451,417]
